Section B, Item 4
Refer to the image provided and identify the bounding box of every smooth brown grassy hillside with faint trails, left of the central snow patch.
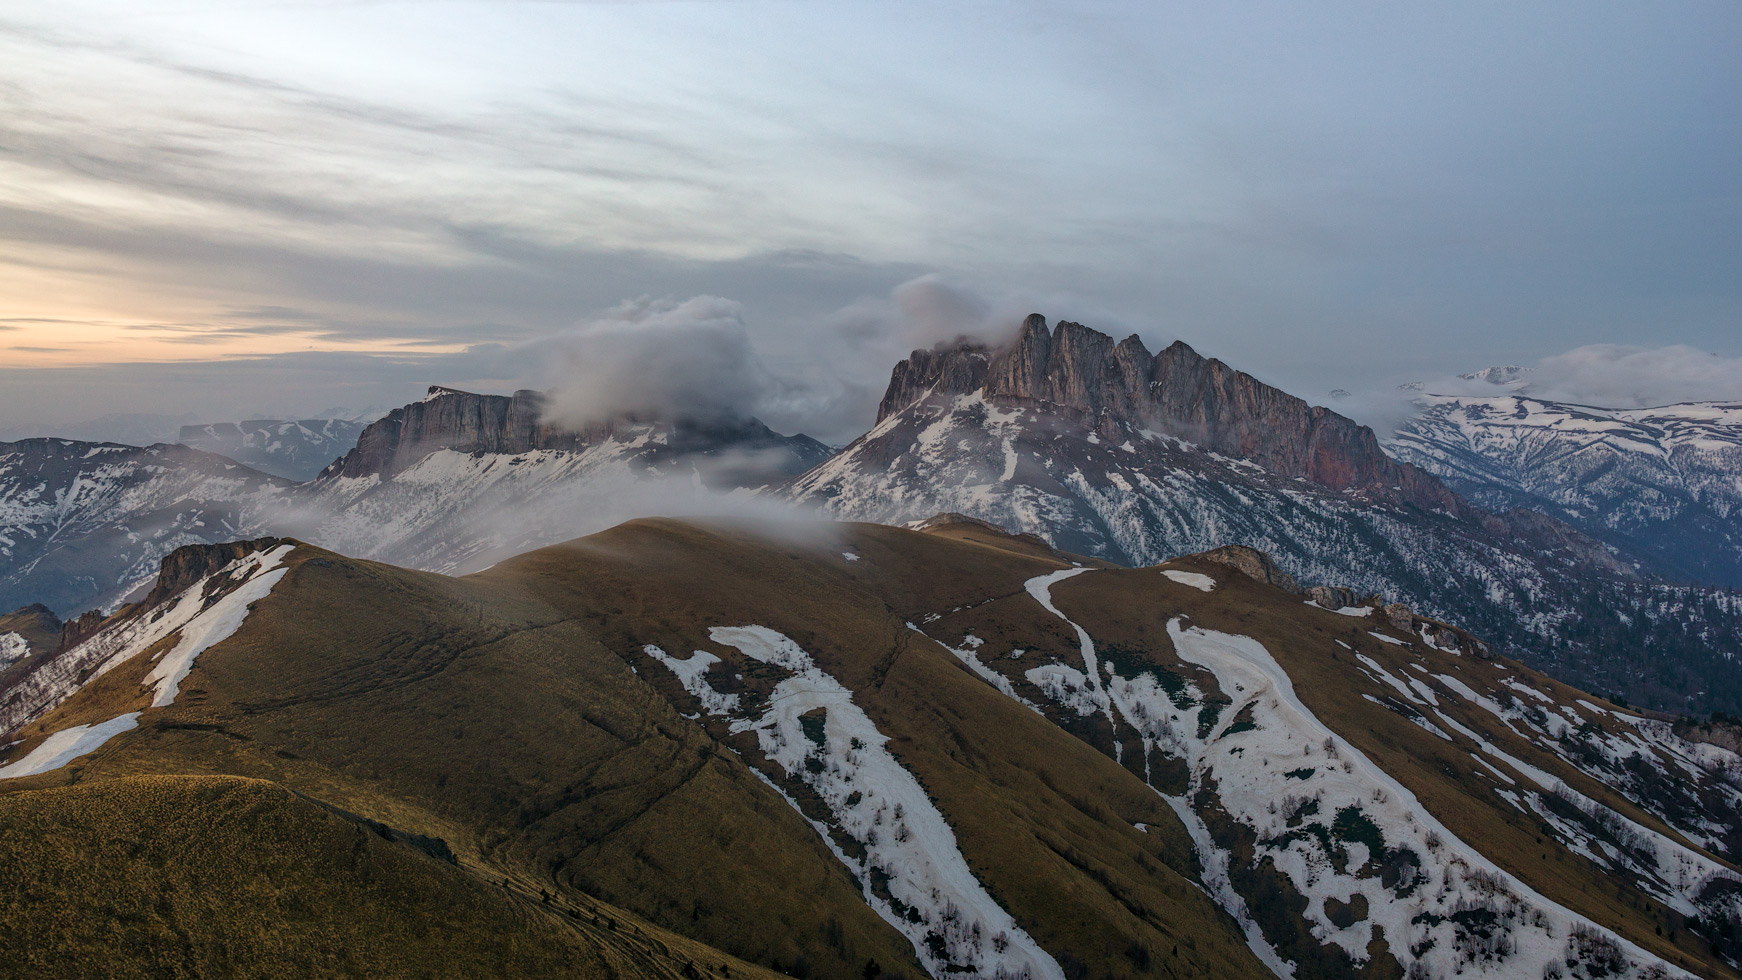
[33,548,920,977]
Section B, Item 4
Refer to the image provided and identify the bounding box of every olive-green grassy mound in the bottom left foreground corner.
[0,776,772,978]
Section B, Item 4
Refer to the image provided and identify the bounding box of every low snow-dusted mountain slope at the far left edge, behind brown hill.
[0,439,289,616]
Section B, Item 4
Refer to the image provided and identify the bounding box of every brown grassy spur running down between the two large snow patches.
[498,522,1265,977]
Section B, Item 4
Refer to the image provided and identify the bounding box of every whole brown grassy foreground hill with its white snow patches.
[0,518,1742,980]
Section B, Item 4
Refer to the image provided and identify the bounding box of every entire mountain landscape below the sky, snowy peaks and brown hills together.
[10,315,1742,980]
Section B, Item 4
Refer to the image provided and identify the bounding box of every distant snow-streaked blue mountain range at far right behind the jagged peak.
[1388,393,1742,588]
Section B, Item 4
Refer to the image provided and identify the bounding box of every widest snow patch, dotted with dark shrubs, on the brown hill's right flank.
[1030,576,1685,978]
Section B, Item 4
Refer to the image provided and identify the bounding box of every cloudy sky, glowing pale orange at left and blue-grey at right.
[0,0,1742,440]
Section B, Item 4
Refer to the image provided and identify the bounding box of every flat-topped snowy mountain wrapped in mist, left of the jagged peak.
[292,386,831,573]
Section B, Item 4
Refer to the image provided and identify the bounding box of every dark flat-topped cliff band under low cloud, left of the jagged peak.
[321,385,829,479]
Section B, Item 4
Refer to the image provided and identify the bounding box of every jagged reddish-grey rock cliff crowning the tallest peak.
[878,313,1477,517]
